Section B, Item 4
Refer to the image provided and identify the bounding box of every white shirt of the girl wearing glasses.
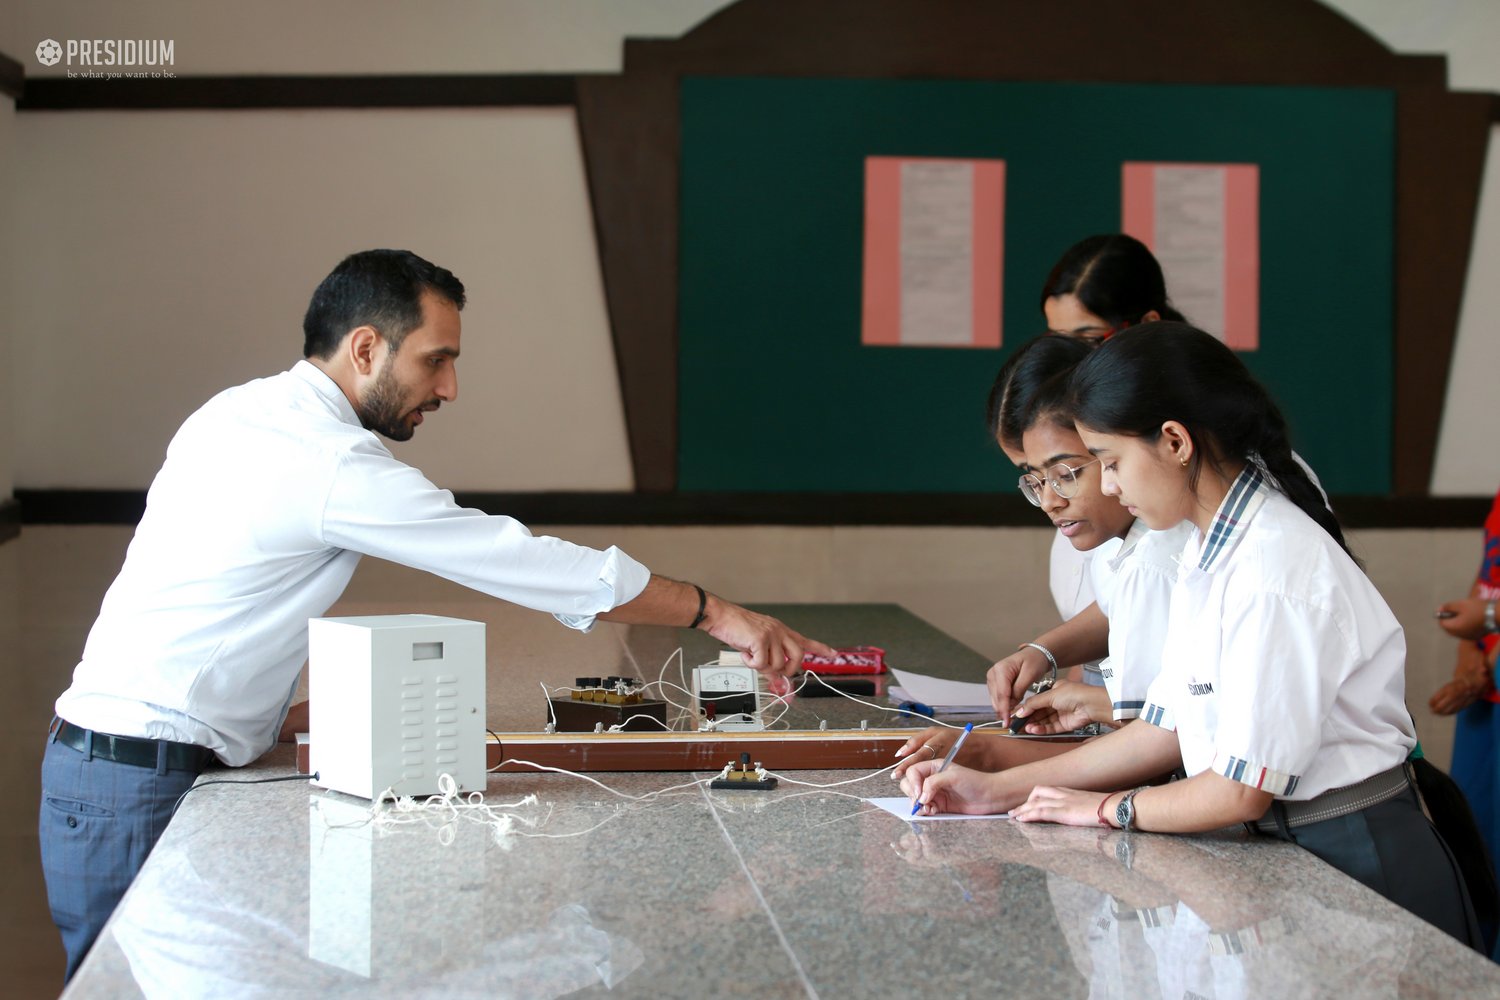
[1092,517,1193,721]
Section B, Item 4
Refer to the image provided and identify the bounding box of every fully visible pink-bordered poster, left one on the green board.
[861,156,1005,348]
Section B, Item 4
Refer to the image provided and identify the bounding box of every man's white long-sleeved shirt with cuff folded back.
[57,361,650,765]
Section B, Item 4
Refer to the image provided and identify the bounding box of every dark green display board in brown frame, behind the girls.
[678,78,1395,495]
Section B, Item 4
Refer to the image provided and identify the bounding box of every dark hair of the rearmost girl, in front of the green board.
[1041,232,1184,328]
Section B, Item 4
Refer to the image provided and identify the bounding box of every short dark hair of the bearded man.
[302,250,464,358]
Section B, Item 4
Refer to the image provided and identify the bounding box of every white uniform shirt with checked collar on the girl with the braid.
[1142,465,1416,801]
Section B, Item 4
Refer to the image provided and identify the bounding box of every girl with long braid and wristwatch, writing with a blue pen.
[903,324,1482,948]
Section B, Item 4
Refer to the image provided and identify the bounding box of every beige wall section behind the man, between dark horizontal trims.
[15,108,633,490]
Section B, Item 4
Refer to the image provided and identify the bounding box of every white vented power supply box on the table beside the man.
[308,615,486,799]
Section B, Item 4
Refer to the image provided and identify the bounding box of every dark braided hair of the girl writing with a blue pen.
[1071,322,1353,558]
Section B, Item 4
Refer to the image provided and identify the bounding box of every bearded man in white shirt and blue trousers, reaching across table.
[41,250,833,978]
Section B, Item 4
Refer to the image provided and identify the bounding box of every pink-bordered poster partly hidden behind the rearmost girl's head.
[1121,163,1260,351]
